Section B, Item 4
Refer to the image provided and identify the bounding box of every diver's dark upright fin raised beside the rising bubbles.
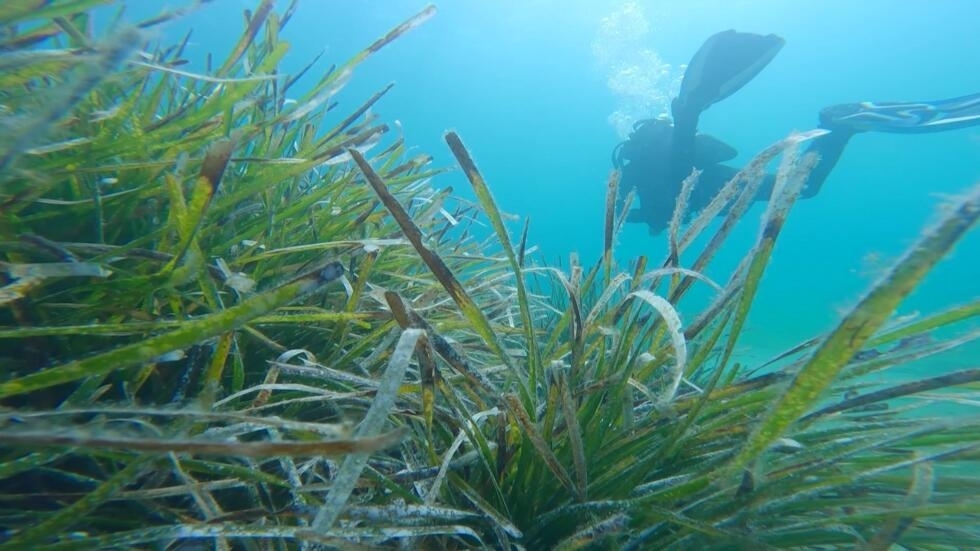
[671,30,785,137]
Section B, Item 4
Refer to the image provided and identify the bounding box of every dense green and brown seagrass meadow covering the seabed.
[0,0,980,550]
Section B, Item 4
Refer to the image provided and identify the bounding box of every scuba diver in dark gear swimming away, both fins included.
[613,30,980,235]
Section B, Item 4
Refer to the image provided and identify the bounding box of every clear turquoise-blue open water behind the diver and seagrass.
[118,0,980,370]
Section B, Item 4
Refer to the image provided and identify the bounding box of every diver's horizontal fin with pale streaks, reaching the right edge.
[820,93,980,134]
